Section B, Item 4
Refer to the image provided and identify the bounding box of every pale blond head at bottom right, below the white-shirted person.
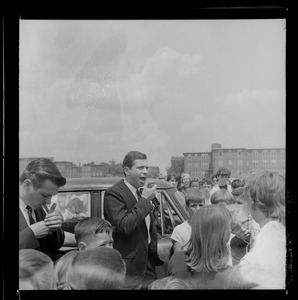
[224,264,284,290]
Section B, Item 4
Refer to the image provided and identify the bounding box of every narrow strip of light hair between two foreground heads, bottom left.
[54,250,78,290]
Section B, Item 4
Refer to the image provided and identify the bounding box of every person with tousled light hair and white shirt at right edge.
[240,170,286,288]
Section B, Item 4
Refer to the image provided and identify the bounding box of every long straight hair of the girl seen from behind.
[185,205,232,272]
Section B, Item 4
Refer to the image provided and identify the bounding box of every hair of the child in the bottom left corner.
[19,249,54,290]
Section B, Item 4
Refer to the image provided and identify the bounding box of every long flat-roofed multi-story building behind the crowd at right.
[183,144,286,179]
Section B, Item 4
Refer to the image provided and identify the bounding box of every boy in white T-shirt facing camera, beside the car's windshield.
[171,187,207,253]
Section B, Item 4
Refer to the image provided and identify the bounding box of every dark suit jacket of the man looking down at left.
[19,208,65,257]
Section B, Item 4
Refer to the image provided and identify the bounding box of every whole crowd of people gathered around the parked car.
[19,151,286,290]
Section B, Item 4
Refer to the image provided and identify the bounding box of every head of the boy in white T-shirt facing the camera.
[185,187,206,219]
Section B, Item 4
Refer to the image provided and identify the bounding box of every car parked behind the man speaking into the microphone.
[51,177,188,278]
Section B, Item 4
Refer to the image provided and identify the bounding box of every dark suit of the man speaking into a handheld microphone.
[104,180,163,287]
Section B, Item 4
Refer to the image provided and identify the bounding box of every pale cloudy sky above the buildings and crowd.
[19,19,286,174]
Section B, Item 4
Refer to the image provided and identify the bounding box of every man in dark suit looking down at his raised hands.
[19,158,66,258]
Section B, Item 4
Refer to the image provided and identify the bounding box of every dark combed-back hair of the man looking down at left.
[20,158,66,188]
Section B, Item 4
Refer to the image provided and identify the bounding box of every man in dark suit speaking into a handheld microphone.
[104,151,163,289]
